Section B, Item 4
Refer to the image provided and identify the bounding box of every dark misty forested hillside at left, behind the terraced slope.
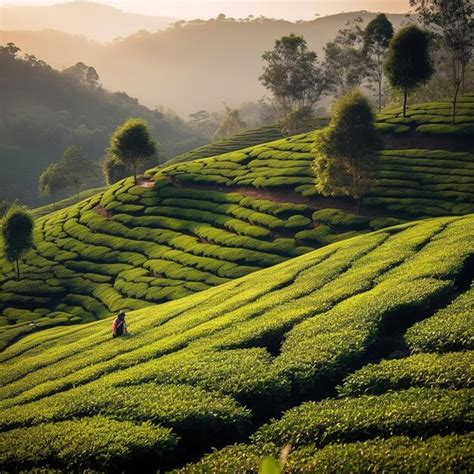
[0,43,207,205]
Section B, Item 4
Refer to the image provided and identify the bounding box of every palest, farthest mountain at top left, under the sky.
[0,1,175,41]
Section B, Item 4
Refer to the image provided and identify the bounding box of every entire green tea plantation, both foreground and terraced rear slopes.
[0,95,474,473]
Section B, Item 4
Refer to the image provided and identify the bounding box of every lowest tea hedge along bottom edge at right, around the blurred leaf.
[179,434,473,474]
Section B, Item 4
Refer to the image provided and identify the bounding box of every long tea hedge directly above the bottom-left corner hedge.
[0,383,250,437]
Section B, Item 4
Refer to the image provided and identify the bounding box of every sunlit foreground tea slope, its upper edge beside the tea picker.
[0,214,474,472]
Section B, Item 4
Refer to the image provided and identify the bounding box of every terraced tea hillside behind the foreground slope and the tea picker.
[0,99,474,347]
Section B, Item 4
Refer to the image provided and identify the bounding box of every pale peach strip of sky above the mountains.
[0,0,409,20]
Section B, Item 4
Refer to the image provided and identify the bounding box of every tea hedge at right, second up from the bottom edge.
[252,388,474,447]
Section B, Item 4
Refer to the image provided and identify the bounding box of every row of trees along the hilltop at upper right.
[259,0,474,131]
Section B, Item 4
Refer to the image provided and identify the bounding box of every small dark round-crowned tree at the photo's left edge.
[2,206,33,280]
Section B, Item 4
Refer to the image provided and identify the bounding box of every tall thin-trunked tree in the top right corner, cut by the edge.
[410,0,474,124]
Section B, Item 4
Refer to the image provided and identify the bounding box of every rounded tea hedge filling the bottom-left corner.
[0,416,176,470]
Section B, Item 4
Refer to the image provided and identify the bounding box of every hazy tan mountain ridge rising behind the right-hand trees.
[0,12,406,115]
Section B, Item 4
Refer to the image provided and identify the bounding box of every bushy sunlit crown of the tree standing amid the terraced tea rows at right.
[313,91,380,199]
